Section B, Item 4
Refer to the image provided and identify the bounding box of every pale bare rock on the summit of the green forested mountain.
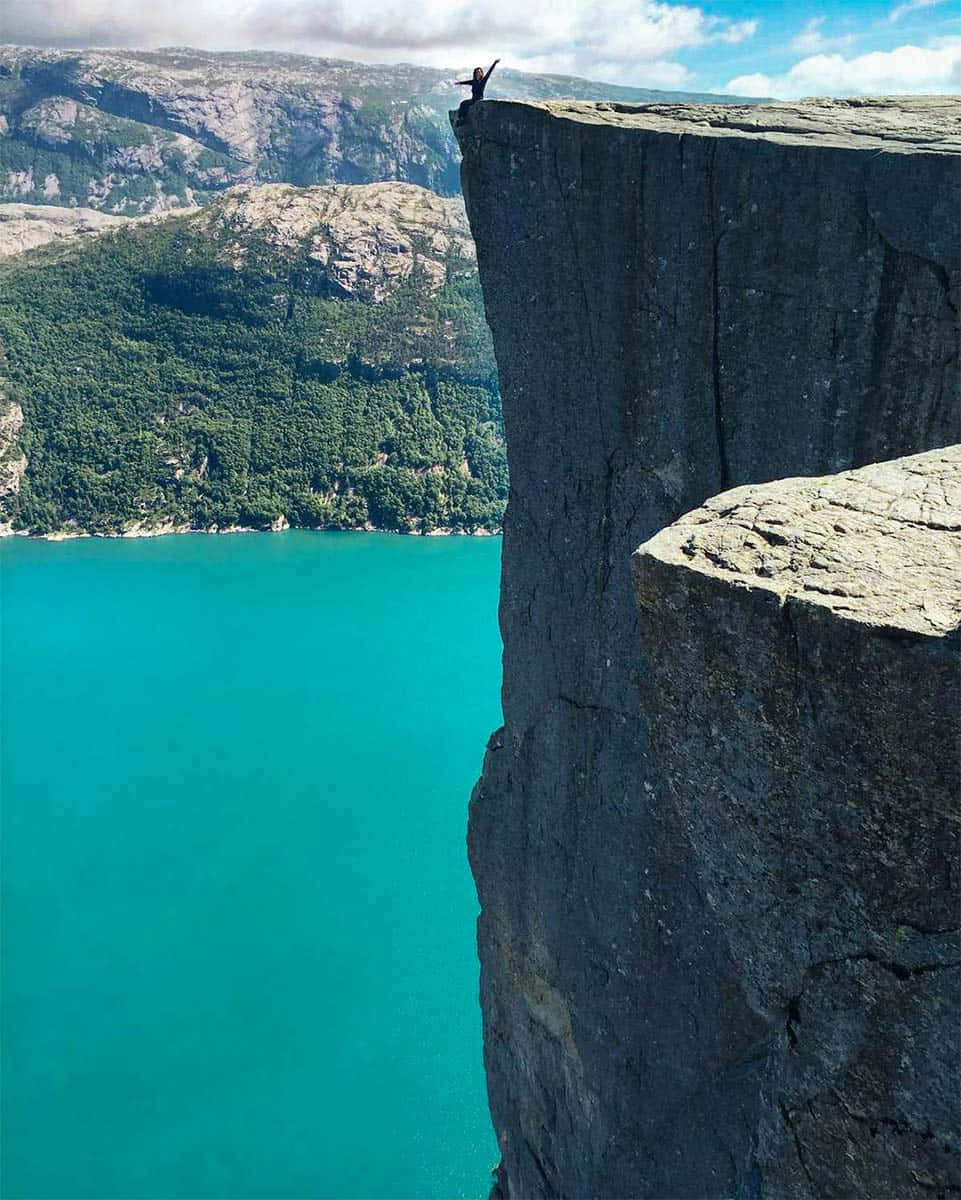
[197,184,474,300]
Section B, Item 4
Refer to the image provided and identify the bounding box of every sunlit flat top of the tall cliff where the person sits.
[485,96,961,155]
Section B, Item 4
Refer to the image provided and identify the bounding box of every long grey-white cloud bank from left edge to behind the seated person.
[0,0,758,86]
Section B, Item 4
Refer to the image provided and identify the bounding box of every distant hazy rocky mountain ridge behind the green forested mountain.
[0,46,758,215]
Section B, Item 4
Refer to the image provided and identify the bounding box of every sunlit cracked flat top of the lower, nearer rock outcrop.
[636,446,961,637]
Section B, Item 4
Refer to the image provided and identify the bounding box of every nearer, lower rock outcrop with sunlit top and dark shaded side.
[633,446,961,1198]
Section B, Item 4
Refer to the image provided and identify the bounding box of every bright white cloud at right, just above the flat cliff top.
[725,37,961,100]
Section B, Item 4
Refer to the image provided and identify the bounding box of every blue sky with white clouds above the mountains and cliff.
[0,0,961,97]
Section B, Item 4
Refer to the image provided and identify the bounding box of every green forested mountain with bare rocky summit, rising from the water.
[0,182,507,533]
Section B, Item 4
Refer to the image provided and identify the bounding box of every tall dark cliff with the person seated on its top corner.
[458,101,961,1198]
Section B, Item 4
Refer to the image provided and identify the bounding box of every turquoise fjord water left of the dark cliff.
[0,533,500,1200]
